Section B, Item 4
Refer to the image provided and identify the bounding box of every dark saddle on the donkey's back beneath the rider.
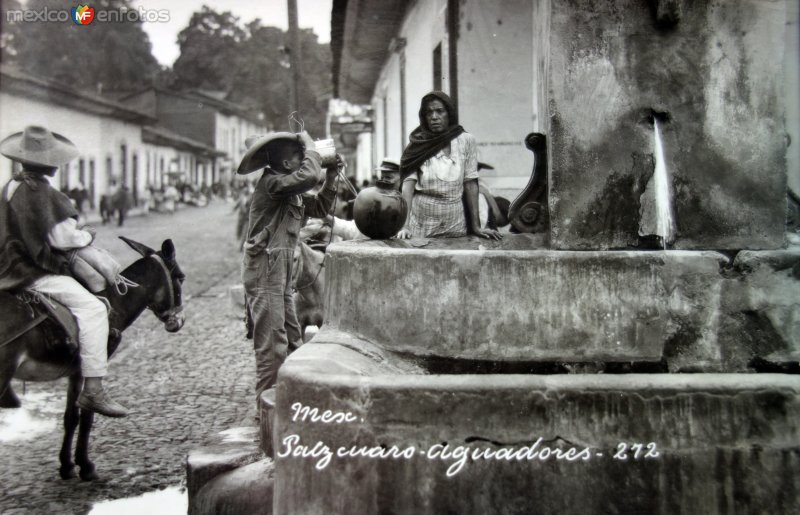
[0,291,78,350]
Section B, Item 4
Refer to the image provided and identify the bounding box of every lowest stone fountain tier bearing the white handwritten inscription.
[270,338,800,514]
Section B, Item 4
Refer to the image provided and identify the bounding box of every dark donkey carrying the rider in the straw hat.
[0,236,184,480]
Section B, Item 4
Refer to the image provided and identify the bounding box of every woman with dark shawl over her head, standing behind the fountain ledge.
[398,91,501,240]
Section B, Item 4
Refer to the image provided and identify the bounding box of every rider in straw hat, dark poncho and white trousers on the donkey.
[0,126,127,417]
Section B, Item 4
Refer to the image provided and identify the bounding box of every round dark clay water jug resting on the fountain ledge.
[353,161,408,240]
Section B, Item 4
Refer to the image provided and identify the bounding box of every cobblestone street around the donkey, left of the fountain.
[0,200,254,513]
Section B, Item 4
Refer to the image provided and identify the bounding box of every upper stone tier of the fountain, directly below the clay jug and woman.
[325,235,728,369]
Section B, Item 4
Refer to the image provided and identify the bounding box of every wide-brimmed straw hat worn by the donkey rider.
[0,125,80,168]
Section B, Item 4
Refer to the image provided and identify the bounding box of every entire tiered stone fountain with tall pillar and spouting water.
[189,0,800,513]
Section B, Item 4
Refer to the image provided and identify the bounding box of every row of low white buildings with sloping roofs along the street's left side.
[0,67,234,209]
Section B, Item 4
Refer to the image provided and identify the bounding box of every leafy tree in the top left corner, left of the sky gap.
[2,0,160,90]
